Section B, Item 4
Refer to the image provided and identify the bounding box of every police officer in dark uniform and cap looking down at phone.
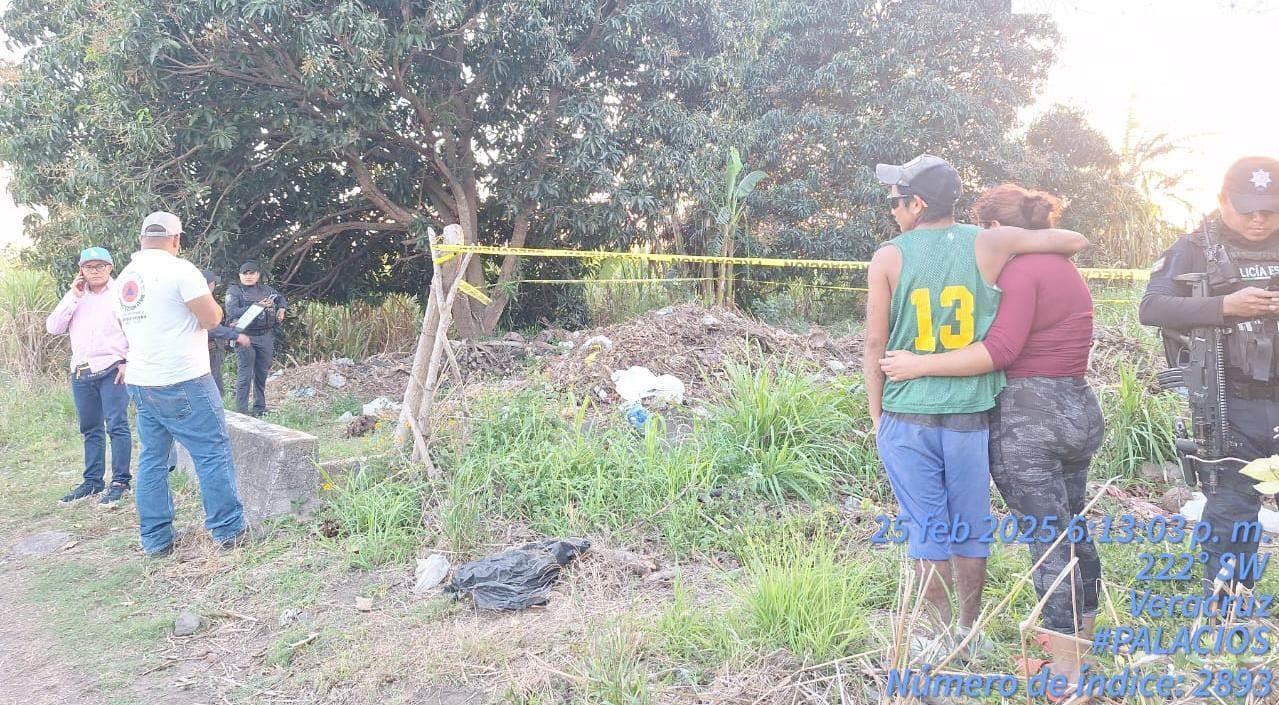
[1141,157,1279,591]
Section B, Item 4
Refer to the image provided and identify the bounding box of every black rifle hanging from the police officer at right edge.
[1157,274,1230,494]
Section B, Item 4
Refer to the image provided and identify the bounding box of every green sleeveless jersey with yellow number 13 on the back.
[884,224,1004,413]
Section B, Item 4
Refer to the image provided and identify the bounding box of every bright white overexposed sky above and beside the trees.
[0,0,1279,248]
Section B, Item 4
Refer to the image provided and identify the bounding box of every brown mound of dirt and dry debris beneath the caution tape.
[547,305,862,402]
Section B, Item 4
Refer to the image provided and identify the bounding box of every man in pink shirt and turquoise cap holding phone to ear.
[45,247,133,507]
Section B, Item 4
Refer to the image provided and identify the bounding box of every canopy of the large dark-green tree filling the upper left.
[0,0,719,334]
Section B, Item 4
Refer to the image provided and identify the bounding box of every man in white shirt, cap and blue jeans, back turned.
[115,211,246,555]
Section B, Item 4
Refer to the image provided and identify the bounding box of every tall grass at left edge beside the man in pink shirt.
[0,265,69,379]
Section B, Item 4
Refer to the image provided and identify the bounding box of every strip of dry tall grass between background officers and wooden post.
[290,294,422,361]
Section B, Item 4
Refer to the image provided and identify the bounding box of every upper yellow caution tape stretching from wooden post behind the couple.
[432,243,1150,281]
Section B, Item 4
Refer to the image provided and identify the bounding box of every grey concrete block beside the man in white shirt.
[178,411,324,525]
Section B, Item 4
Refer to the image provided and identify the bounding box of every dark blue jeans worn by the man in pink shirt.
[72,365,133,490]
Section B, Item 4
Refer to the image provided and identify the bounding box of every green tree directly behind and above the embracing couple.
[700,0,1055,266]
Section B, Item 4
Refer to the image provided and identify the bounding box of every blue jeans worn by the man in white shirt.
[129,375,244,553]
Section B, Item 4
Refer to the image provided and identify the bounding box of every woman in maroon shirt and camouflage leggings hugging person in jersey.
[881,184,1104,696]
